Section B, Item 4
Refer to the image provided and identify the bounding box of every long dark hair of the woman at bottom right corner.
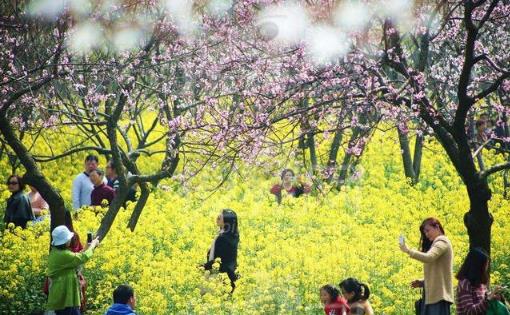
[456,247,489,287]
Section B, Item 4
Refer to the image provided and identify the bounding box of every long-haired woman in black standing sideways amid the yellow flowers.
[204,209,239,292]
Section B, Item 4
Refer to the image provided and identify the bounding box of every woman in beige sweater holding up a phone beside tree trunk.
[400,218,454,315]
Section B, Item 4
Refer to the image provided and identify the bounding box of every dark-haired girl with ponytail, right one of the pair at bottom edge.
[339,278,374,315]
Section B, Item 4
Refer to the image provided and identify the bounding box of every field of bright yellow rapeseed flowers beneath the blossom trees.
[0,133,510,314]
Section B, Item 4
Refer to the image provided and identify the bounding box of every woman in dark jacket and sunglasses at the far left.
[4,175,35,229]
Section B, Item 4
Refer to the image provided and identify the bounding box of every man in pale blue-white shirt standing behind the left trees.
[72,154,106,210]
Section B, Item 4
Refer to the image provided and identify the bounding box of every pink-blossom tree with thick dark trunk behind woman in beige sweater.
[368,1,510,251]
